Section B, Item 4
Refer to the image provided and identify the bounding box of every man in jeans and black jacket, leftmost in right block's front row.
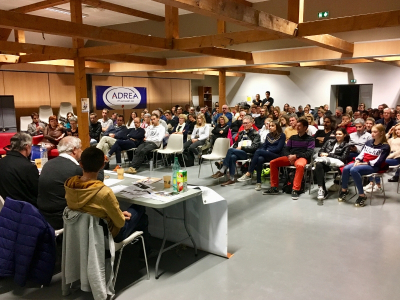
[212,116,261,186]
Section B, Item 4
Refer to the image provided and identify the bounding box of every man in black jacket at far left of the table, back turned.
[0,132,39,206]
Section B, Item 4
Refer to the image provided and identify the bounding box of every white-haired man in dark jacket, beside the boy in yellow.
[37,137,104,230]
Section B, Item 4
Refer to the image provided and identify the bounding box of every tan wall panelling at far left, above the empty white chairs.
[3,72,50,128]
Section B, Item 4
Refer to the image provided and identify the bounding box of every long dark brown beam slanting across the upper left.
[0,10,167,49]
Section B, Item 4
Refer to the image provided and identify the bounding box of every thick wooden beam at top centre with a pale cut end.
[153,0,297,36]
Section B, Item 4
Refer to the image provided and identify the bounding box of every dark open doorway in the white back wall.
[330,84,372,111]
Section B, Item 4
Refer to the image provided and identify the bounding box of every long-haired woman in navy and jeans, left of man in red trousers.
[238,122,286,191]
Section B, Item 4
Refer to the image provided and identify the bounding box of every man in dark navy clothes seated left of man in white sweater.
[106,118,146,171]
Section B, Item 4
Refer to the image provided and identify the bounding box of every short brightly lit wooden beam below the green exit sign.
[299,34,354,54]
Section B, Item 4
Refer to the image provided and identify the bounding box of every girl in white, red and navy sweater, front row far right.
[338,124,390,206]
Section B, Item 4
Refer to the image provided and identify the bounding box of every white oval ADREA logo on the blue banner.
[103,86,142,108]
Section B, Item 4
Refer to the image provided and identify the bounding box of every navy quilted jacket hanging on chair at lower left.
[0,197,56,286]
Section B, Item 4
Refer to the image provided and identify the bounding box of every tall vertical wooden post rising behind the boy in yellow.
[70,0,90,149]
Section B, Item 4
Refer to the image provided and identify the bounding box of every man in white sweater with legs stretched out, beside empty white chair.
[126,114,165,174]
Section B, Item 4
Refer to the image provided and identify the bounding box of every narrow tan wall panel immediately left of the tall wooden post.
[49,74,76,114]
